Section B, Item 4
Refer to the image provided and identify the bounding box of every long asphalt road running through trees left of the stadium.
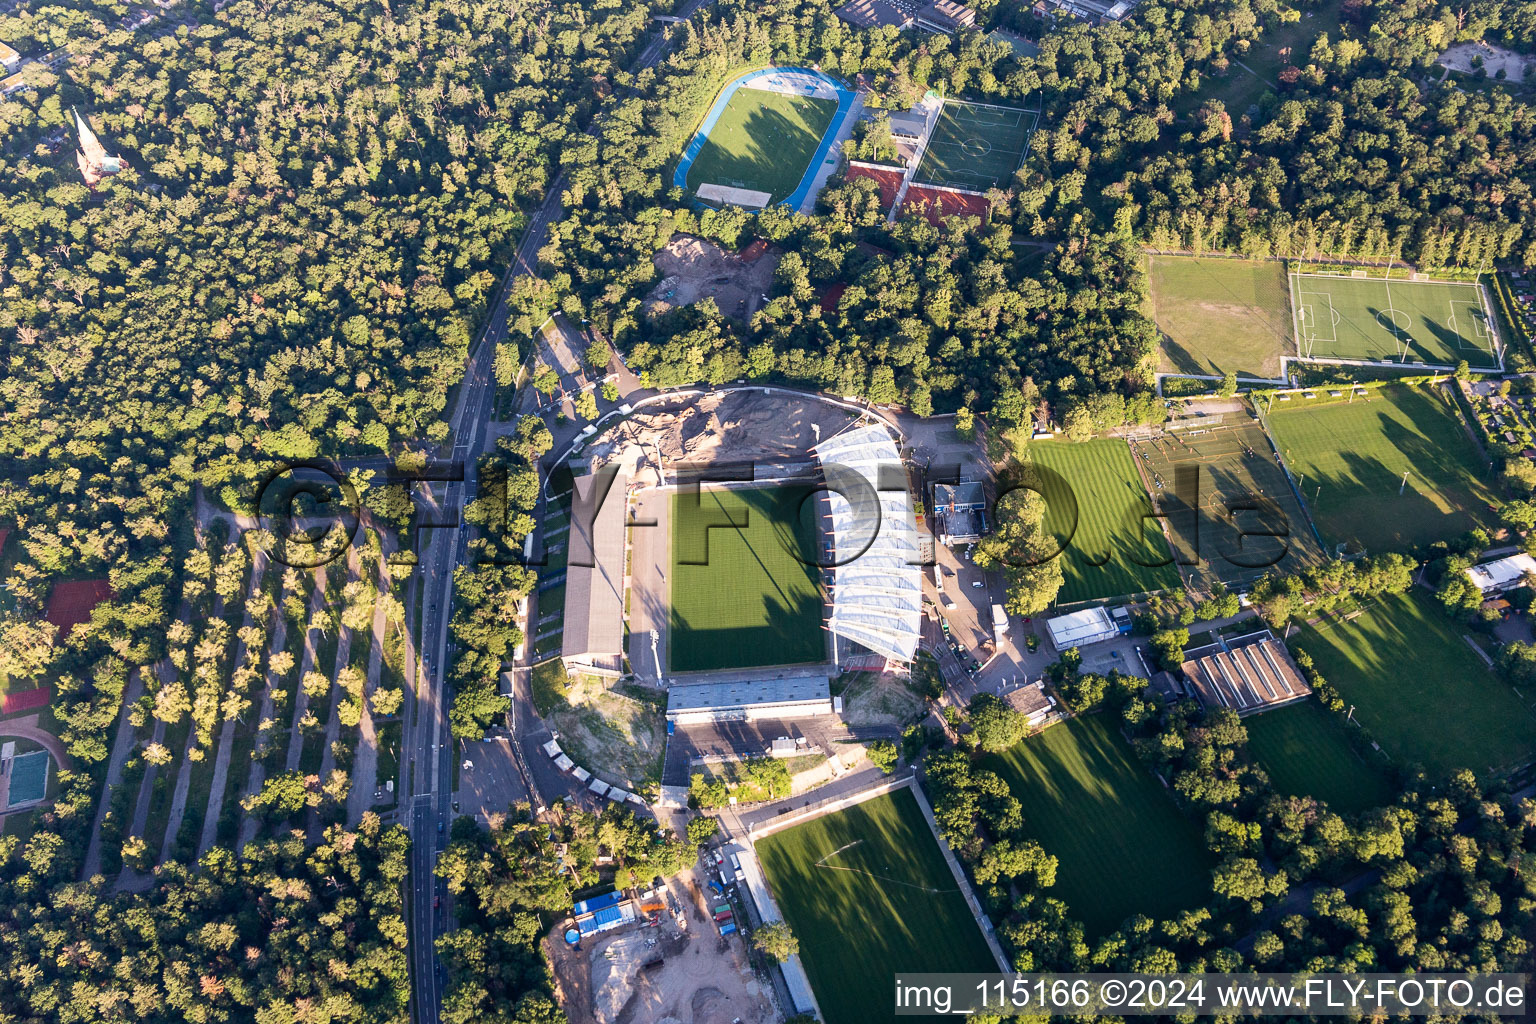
[401,10,707,1024]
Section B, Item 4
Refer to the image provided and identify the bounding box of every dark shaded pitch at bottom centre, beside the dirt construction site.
[756,789,997,1024]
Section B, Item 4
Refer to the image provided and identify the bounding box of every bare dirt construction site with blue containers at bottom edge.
[545,870,779,1024]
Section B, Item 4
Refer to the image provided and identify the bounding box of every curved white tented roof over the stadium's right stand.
[816,427,923,662]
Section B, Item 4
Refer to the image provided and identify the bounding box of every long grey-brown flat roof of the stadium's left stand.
[561,467,628,677]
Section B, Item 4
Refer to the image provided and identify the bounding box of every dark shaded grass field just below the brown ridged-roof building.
[1243,700,1395,814]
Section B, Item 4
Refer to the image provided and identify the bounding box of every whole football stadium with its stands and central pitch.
[561,399,923,726]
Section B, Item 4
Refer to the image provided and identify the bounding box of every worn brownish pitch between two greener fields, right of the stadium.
[1132,411,1322,588]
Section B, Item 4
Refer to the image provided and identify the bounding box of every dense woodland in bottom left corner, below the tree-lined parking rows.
[0,815,410,1024]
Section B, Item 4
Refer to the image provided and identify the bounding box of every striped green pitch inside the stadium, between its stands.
[668,487,826,672]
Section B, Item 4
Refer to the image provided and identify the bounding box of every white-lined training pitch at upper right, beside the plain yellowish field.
[1290,273,1499,370]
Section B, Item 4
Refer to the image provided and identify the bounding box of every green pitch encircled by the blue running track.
[688,89,837,203]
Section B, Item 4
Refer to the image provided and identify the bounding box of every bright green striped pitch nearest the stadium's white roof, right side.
[1028,439,1178,603]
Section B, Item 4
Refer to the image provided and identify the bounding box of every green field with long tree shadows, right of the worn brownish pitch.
[1269,384,1498,551]
